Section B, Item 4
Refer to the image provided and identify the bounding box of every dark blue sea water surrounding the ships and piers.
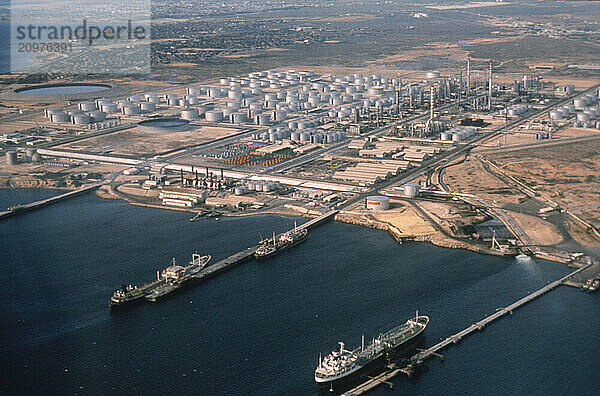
[0,190,600,395]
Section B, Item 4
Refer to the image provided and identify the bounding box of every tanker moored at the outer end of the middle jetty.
[108,254,211,308]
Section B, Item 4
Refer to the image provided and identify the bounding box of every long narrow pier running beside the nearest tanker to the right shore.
[343,263,593,396]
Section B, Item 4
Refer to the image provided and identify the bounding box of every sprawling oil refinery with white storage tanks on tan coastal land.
[0,60,600,286]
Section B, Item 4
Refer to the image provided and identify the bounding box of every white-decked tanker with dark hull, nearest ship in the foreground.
[315,312,429,387]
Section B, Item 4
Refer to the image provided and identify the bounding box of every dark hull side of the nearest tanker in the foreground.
[315,330,425,392]
